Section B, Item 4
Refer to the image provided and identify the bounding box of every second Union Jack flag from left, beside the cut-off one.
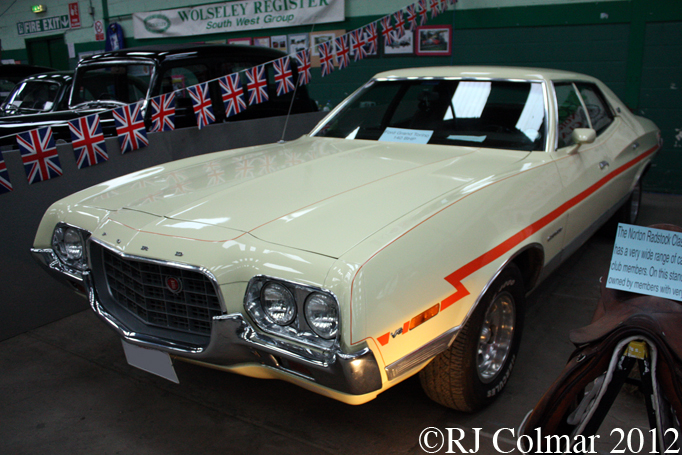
[17,126,62,185]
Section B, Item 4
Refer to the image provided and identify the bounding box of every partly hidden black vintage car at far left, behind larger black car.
[0,71,73,116]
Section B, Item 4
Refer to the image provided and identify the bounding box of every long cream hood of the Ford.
[79,137,527,258]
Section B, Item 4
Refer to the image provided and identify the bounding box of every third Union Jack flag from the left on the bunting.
[69,114,109,169]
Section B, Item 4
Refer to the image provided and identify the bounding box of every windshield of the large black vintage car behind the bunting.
[69,63,154,107]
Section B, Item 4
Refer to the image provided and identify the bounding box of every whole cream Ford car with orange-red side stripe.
[32,67,660,411]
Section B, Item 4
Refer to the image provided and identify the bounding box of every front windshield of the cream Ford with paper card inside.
[313,78,546,151]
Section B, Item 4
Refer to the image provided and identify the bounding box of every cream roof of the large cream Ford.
[374,66,596,82]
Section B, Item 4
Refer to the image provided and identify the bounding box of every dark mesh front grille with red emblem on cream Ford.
[102,248,222,336]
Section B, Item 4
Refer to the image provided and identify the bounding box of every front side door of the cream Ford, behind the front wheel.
[553,82,617,254]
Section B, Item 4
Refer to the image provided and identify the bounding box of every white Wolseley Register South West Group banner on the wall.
[133,0,345,39]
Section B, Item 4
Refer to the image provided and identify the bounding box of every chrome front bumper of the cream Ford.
[32,249,382,402]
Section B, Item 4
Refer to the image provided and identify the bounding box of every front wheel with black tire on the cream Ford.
[419,264,525,412]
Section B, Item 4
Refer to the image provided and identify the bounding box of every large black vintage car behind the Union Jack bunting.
[0,44,317,148]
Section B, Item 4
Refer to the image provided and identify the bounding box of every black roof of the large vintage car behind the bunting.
[80,43,285,64]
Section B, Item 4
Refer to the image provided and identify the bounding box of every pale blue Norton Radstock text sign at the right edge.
[606,224,682,301]
